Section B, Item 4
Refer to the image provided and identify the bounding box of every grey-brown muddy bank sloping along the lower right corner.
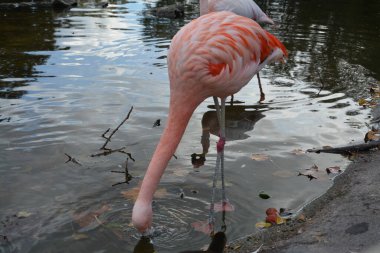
[228,151,380,253]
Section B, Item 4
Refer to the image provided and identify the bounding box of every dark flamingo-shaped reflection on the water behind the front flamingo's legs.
[191,105,266,167]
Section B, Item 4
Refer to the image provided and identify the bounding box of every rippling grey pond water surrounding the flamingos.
[0,0,380,252]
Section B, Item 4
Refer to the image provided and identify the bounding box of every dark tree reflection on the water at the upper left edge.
[0,8,54,98]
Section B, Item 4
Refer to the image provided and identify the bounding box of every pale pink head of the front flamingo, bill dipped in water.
[132,199,153,234]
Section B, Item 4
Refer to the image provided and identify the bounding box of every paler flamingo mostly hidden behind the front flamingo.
[206,0,274,101]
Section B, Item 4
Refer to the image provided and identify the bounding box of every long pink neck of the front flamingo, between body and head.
[138,98,196,203]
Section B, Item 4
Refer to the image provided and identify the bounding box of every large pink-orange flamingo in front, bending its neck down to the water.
[132,7,287,232]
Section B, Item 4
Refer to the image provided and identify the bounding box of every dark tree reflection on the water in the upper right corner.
[273,0,380,99]
